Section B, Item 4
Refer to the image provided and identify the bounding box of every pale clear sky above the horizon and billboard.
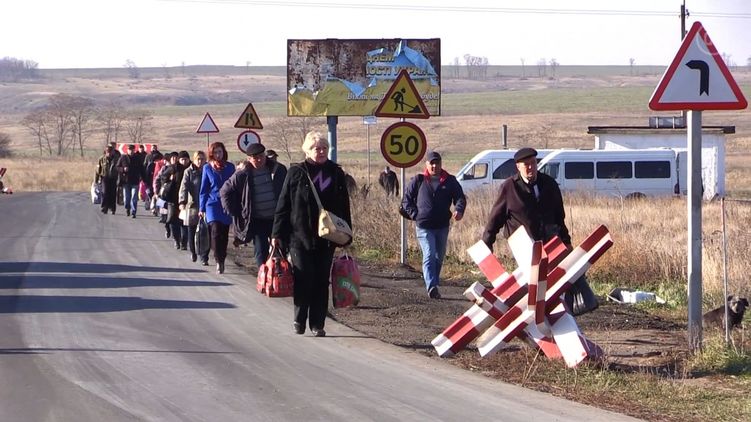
[5,0,751,69]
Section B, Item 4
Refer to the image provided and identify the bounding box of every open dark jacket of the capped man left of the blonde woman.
[219,160,287,243]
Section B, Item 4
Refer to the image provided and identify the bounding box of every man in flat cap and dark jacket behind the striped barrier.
[482,147,598,315]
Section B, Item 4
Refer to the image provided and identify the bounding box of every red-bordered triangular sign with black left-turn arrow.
[649,22,748,110]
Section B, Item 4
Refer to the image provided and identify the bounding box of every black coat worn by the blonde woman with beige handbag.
[271,160,352,250]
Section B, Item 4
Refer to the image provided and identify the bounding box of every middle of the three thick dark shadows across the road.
[0,275,233,289]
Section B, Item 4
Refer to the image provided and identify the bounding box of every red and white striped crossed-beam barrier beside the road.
[431,226,613,367]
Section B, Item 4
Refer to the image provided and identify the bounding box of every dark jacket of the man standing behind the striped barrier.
[482,173,571,248]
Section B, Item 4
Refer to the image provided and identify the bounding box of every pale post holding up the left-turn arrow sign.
[687,110,703,352]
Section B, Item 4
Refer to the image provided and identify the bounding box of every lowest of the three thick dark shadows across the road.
[0,295,235,314]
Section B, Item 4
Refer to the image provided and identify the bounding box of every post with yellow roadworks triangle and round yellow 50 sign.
[374,69,430,264]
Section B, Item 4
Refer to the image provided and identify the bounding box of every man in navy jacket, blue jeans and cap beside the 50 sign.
[400,151,467,299]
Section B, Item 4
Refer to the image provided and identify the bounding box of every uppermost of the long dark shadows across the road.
[0,262,204,274]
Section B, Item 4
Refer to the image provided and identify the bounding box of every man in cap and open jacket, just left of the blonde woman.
[219,143,287,267]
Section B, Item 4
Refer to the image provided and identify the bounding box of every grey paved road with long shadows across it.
[0,193,648,422]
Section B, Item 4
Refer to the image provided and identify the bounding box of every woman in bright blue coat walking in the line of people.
[198,142,235,274]
